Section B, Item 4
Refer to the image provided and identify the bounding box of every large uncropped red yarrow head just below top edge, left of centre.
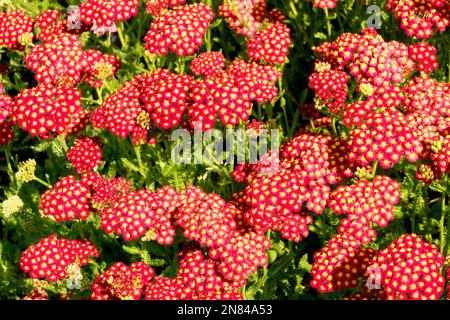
[144,3,214,56]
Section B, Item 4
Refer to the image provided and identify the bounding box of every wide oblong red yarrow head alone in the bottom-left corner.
[20,234,99,282]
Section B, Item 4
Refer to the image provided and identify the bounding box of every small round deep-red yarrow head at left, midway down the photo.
[66,136,103,173]
